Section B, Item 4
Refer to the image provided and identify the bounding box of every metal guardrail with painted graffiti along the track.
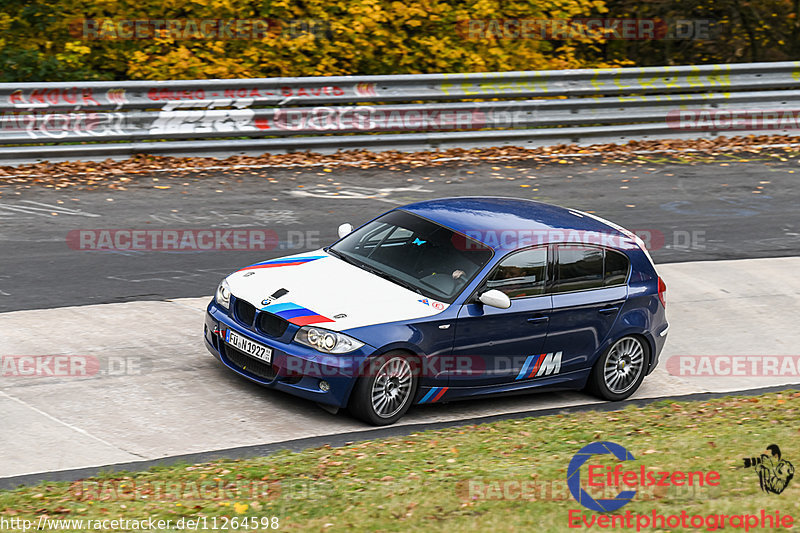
[0,61,800,163]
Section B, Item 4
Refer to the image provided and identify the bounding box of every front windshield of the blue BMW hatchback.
[328,210,492,303]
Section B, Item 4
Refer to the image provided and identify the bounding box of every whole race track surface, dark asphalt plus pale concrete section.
[0,154,800,478]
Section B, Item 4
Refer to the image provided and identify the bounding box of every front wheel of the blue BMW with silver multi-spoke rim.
[348,351,418,426]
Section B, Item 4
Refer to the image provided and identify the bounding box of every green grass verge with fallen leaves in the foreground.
[0,391,800,531]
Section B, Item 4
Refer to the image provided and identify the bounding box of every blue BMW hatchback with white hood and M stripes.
[205,197,669,425]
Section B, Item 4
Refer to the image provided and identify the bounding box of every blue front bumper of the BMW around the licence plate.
[204,299,375,407]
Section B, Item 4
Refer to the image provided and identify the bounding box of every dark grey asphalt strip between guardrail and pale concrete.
[0,154,800,312]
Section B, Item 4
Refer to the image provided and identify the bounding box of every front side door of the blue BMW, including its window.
[449,246,552,387]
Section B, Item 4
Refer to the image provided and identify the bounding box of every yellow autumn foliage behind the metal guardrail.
[0,0,624,79]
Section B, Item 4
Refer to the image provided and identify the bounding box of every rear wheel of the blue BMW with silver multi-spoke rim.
[586,335,650,402]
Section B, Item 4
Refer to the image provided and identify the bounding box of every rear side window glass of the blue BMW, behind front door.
[553,245,628,292]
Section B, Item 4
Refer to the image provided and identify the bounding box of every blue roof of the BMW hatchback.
[398,196,627,249]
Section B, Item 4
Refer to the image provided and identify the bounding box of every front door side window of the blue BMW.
[486,247,547,299]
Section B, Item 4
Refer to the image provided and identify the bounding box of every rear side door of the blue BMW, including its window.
[544,244,630,374]
